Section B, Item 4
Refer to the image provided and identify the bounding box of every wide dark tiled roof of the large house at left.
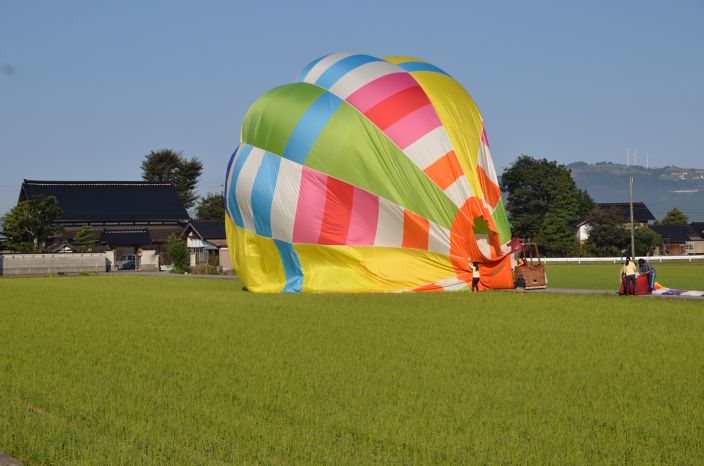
[19,180,189,222]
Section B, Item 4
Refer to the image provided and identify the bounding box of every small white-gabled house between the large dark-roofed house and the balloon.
[181,220,232,270]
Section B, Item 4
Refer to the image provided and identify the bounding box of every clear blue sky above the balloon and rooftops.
[0,0,704,215]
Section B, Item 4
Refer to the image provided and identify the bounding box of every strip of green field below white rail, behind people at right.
[546,261,704,291]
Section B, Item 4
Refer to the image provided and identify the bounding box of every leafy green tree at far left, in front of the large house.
[2,196,63,252]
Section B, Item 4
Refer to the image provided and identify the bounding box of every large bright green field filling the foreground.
[0,269,704,465]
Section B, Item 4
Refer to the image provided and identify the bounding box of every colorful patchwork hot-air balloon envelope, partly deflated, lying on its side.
[225,53,513,292]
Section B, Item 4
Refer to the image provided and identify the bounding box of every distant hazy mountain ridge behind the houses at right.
[567,162,704,222]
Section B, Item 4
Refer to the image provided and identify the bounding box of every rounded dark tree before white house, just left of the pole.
[585,207,631,257]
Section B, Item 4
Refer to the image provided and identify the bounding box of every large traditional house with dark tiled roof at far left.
[18,180,190,268]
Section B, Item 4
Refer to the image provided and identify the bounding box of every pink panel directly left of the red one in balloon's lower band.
[293,167,328,244]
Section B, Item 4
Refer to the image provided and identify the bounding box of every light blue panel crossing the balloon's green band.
[283,92,342,165]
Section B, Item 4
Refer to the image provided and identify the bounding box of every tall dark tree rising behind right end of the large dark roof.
[142,149,203,209]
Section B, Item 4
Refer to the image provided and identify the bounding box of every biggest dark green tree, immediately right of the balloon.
[501,154,594,255]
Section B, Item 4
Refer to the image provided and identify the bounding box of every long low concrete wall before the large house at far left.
[0,252,114,275]
